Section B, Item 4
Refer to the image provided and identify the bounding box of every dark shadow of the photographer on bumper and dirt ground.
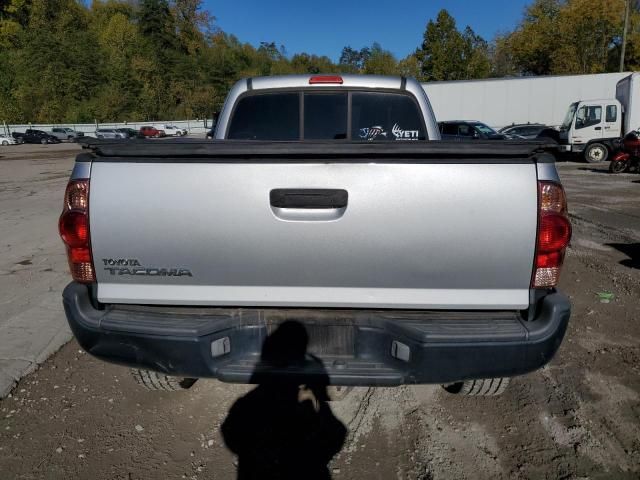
[222,321,347,480]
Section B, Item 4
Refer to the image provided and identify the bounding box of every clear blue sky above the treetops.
[204,0,530,60]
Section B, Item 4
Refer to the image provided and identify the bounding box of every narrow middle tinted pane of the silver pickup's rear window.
[304,92,348,140]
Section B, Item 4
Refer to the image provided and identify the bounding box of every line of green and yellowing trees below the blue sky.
[0,0,640,123]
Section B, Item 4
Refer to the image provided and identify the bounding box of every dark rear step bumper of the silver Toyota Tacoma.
[63,283,570,385]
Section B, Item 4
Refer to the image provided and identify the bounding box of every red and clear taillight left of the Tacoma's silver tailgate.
[58,179,96,283]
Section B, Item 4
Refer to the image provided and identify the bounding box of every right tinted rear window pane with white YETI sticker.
[351,92,426,141]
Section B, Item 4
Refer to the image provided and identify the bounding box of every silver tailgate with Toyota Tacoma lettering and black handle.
[90,150,537,309]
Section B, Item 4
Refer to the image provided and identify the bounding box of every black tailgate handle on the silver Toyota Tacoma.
[269,188,349,210]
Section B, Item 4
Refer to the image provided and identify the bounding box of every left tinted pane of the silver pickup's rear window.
[227,92,300,140]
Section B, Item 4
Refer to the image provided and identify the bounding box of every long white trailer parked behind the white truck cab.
[422,72,630,129]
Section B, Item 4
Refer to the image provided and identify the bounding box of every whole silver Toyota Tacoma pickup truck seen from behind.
[59,75,571,395]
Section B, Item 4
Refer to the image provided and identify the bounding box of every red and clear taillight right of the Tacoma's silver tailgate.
[531,181,571,288]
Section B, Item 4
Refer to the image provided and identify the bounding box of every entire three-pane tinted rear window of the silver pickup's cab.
[227,90,427,141]
